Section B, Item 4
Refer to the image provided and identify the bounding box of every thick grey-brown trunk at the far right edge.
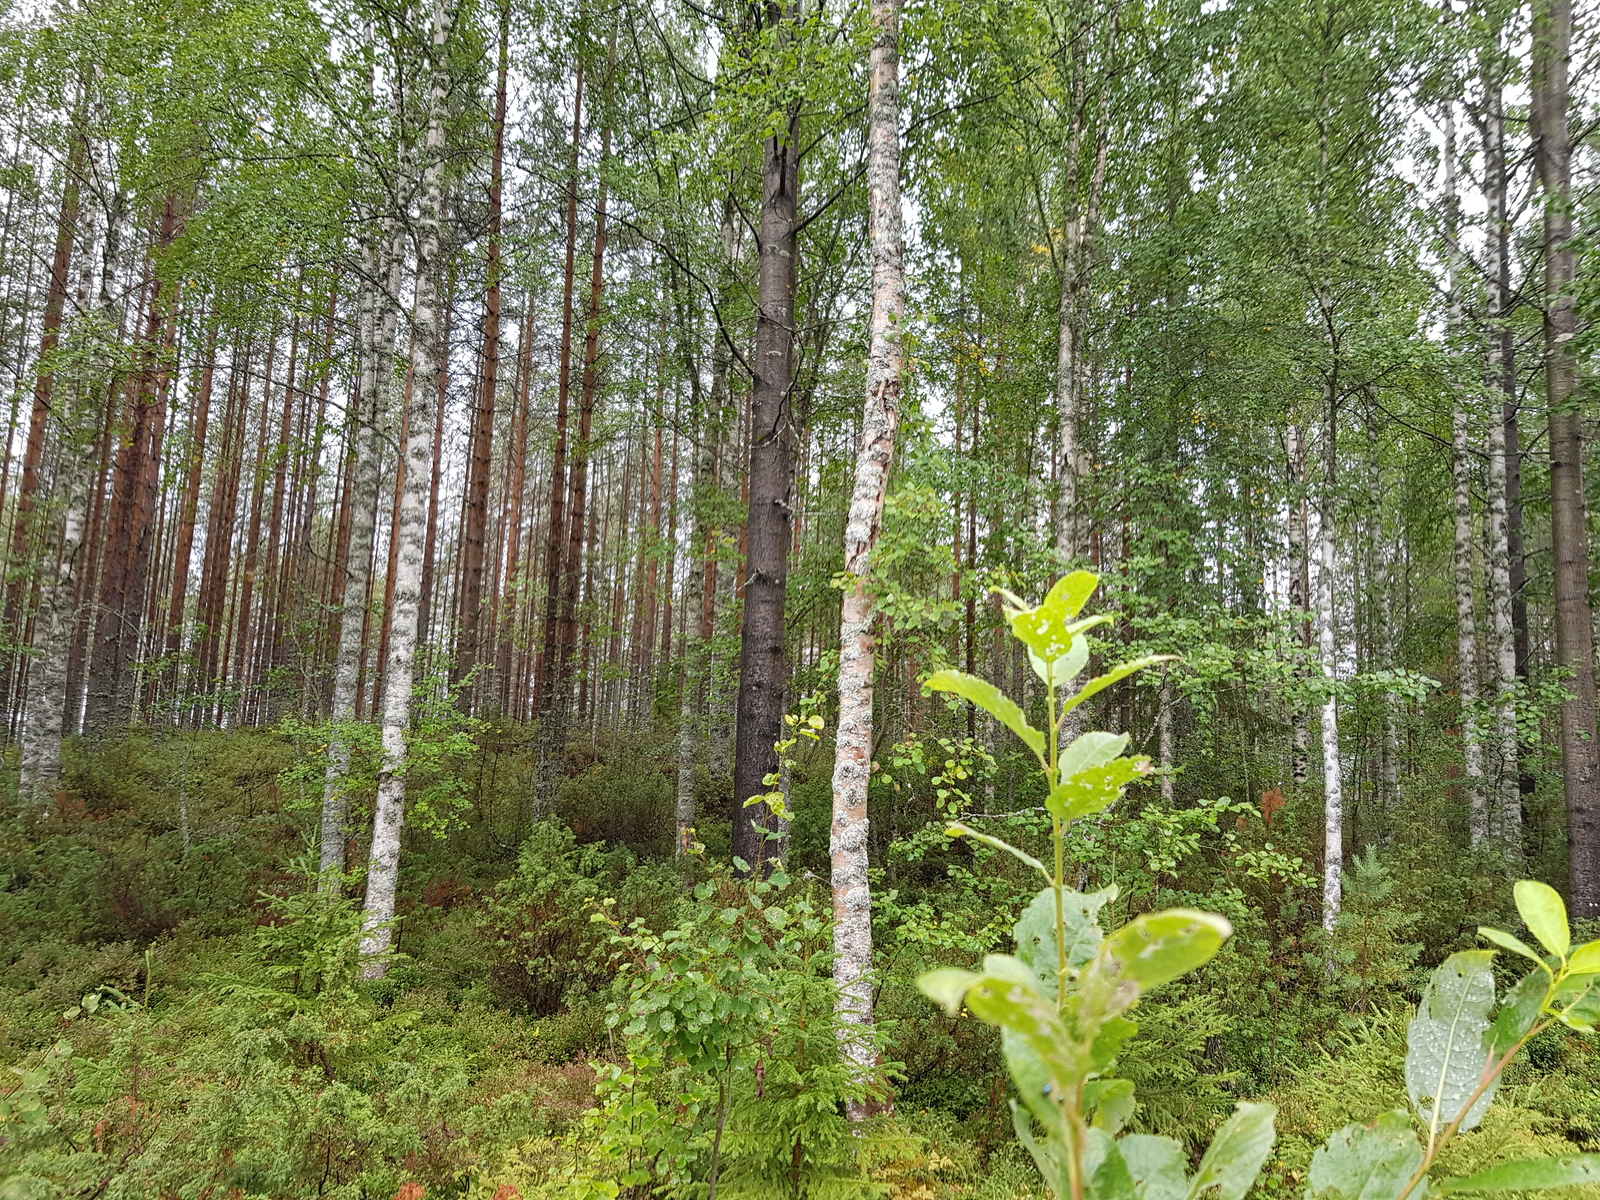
[1533,0,1600,920]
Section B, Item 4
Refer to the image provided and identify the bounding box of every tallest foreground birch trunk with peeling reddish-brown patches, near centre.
[829,0,906,1120]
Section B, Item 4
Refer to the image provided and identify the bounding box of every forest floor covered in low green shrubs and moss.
[0,731,1600,1200]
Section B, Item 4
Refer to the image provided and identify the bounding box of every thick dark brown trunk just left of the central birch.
[733,25,800,869]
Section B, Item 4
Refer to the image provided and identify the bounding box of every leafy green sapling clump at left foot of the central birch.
[570,872,902,1197]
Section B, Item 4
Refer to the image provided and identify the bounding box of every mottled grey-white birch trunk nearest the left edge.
[19,445,88,806]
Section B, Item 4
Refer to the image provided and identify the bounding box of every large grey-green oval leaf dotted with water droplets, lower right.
[1405,950,1494,1133]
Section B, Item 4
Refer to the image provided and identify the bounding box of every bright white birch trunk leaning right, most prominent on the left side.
[362,0,454,978]
